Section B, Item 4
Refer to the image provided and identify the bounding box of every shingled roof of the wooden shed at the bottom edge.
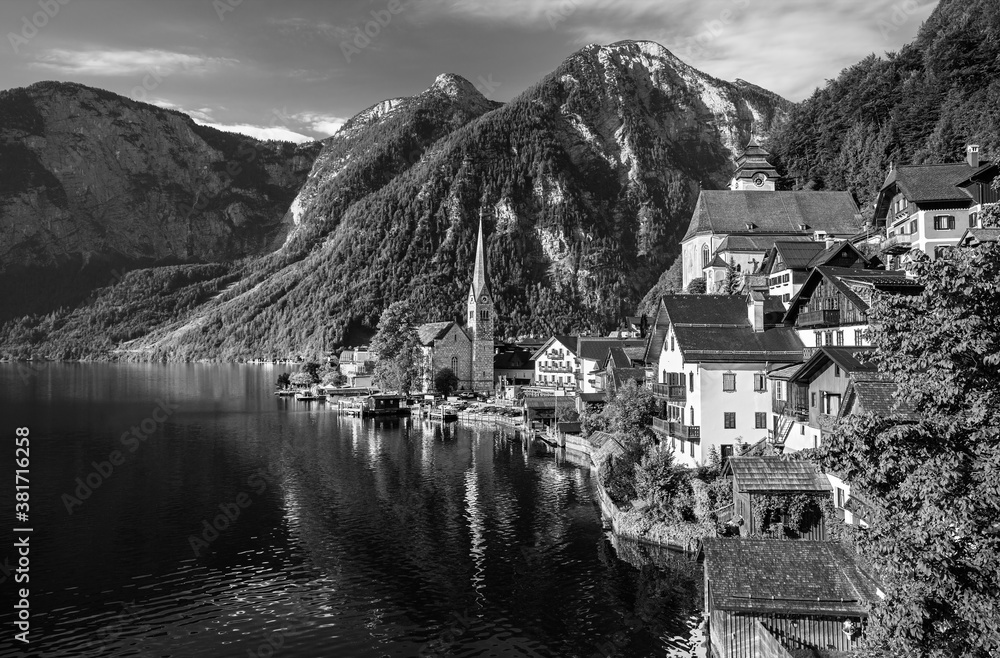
[704,538,878,617]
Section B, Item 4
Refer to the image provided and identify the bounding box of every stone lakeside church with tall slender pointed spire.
[417,217,496,393]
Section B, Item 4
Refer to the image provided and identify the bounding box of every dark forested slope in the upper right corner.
[769,0,1000,215]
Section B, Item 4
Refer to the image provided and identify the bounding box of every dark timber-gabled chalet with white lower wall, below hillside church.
[784,265,923,355]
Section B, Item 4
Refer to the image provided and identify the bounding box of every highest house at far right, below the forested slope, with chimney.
[874,145,1000,267]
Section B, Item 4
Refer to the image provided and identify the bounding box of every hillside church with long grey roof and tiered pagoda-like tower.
[681,143,863,290]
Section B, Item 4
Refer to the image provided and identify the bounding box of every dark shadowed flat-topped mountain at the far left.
[0,82,320,320]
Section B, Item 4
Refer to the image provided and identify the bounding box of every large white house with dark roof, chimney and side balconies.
[644,292,802,466]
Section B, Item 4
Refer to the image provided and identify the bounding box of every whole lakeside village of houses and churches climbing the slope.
[279,141,1000,658]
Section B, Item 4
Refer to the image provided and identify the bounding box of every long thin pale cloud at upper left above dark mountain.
[29,48,239,77]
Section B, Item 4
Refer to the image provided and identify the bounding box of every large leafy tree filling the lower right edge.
[821,243,1000,658]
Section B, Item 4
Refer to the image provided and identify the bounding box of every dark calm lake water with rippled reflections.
[0,364,701,658]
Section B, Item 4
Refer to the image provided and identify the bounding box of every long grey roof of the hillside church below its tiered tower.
[682,190,861,241]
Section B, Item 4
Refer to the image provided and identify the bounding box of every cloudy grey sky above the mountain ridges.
[0,0,938,142]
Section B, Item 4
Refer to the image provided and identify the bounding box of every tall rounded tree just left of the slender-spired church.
[370,301,421,395]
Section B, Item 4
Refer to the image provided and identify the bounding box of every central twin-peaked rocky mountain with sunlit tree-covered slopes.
[0,41,790,360]
